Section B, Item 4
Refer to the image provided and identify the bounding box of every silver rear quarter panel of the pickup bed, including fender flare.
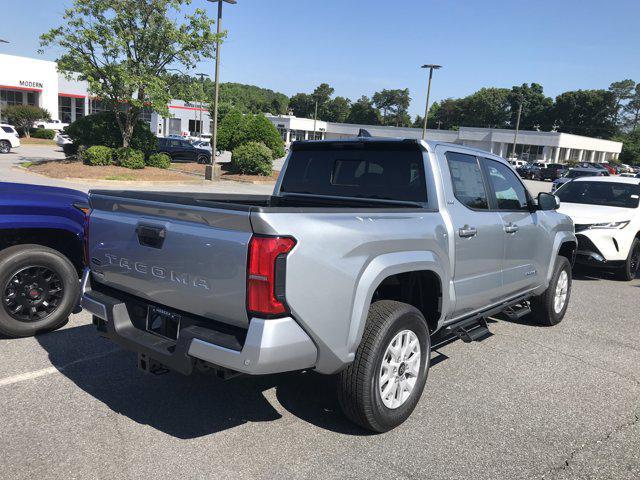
[252,209,450,373]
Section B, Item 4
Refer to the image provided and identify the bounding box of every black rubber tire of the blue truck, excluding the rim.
[0,245,80,337]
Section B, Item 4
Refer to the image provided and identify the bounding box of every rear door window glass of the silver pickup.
[445,152,489,210]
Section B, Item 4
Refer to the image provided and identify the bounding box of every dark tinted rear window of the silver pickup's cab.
[281,144,427,203]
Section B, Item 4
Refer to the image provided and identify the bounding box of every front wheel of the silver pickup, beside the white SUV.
[531,257,572,327]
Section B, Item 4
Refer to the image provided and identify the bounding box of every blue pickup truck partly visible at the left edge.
[0,183,89,337]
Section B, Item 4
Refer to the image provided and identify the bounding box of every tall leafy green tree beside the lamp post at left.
[40,0,217,147]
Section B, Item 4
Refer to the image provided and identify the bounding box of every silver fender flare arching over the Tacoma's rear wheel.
[347,251,449,361]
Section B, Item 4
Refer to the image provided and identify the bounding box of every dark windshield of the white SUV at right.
[556,182,640,208]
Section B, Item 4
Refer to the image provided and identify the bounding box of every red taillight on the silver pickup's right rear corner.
[247,236,296,317]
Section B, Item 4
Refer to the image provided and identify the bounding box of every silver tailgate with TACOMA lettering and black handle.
[88,193,252,327]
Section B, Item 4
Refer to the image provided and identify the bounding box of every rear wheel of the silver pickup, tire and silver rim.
[338,300,431,432]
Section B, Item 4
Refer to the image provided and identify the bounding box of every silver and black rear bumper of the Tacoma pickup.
[81,269,318,375]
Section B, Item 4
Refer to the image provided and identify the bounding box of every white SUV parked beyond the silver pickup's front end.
[555,177,640,281]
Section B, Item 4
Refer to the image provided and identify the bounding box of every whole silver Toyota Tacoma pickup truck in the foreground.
[82,138,577,432]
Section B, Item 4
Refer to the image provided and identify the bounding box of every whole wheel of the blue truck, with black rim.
[0,245,80,337]
